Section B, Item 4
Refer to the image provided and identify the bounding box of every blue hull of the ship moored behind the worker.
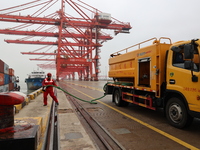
[25,78,45,90]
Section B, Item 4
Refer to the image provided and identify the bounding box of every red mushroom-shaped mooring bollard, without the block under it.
[0,92,25,129]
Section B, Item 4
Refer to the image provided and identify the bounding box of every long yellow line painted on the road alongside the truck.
[66,82,200,150]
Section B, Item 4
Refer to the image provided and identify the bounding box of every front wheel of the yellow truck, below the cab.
[166,97,193,129]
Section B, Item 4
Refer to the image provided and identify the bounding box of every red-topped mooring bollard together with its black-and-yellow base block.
[0,92,41,150]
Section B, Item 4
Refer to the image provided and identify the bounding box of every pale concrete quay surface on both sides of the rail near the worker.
[14,90,98,150]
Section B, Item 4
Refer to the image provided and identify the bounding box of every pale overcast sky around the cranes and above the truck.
[0,0,200,80]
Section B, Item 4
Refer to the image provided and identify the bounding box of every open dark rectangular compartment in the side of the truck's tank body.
[138,58,151,87]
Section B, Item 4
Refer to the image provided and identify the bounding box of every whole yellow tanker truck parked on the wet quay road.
[104,37,200,128]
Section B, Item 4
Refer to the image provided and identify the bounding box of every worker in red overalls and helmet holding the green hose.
[42,73,59,106]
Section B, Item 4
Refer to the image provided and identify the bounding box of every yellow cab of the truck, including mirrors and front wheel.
[164,40,200,127]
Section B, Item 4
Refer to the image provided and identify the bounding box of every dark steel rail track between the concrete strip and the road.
[67,95,125,150]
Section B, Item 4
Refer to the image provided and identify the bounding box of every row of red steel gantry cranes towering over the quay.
[0,0,131,81]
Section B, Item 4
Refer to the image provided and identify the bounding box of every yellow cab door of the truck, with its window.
[167,49,199,90]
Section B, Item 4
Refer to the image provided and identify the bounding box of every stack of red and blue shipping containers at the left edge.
[0,59,17,92]
